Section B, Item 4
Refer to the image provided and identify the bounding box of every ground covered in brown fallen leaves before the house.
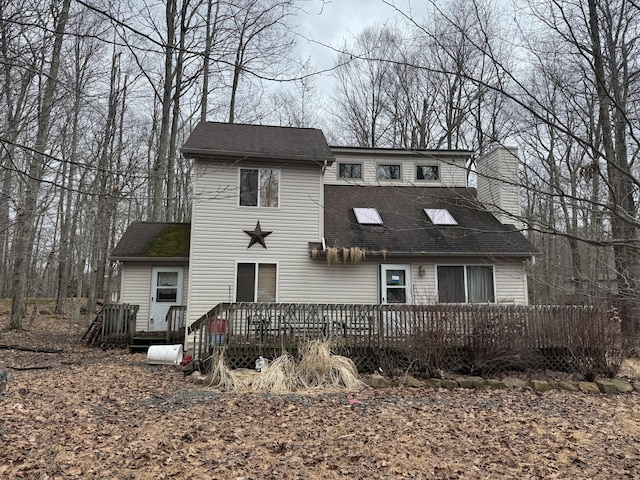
[0,305,640,480]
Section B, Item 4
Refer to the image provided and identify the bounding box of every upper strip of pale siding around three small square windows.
[324,155,467,187]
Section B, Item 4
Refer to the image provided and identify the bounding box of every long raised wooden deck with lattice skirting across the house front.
[186,303,622,370]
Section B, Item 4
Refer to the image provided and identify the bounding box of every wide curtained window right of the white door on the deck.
[438,265,495,303]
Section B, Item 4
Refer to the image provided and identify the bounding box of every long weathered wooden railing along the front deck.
[187,303,620,374]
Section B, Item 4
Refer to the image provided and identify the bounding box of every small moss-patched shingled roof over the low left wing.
[111,222,191,261]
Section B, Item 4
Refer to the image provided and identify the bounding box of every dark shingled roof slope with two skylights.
[325,185,539,256]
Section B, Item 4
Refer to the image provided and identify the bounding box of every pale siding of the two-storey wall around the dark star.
[188,162,323,322]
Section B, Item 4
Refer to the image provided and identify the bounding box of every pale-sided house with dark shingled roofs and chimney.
[111,122,538,348]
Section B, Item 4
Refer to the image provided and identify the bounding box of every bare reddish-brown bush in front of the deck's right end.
[382,305,628,377]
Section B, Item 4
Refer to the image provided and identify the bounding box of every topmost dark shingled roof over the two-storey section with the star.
[181,122,335,165]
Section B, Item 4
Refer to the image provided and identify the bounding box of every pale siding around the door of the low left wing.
[120,263,188,332]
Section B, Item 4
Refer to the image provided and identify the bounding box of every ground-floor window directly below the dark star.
[236,263,277,302]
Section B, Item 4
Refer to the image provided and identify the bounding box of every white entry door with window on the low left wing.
[149,267,184,332]
